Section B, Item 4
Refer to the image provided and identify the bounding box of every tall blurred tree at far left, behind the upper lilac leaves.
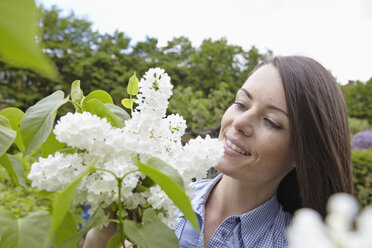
[0,7,135,110]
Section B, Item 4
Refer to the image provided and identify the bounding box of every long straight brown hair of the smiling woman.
[259,56,353,217]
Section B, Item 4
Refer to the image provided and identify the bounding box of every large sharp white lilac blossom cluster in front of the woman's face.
[28,68,224,227]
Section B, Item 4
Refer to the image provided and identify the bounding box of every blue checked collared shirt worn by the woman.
[175,174,291,248]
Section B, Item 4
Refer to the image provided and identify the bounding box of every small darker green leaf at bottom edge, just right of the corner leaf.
[54,211,79,248]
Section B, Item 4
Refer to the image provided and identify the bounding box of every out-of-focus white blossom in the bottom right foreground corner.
[287,193,372,248]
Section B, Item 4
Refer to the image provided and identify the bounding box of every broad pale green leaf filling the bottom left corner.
[0,209,51,248]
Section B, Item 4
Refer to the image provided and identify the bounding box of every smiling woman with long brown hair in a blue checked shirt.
[85,56,353,248]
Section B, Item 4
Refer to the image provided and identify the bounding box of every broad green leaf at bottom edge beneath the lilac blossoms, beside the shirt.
[124,208,179,248]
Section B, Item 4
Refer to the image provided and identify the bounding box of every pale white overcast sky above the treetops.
[36,0,372,84]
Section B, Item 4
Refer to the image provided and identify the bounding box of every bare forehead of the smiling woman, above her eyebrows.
[238,64,287,110]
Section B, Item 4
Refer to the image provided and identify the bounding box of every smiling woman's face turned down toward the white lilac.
[216,64,294,187]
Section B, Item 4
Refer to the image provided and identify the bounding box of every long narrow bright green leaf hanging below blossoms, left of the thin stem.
[49,159,98,237]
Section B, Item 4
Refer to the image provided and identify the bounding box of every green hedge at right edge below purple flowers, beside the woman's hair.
[351,149,372,207]
